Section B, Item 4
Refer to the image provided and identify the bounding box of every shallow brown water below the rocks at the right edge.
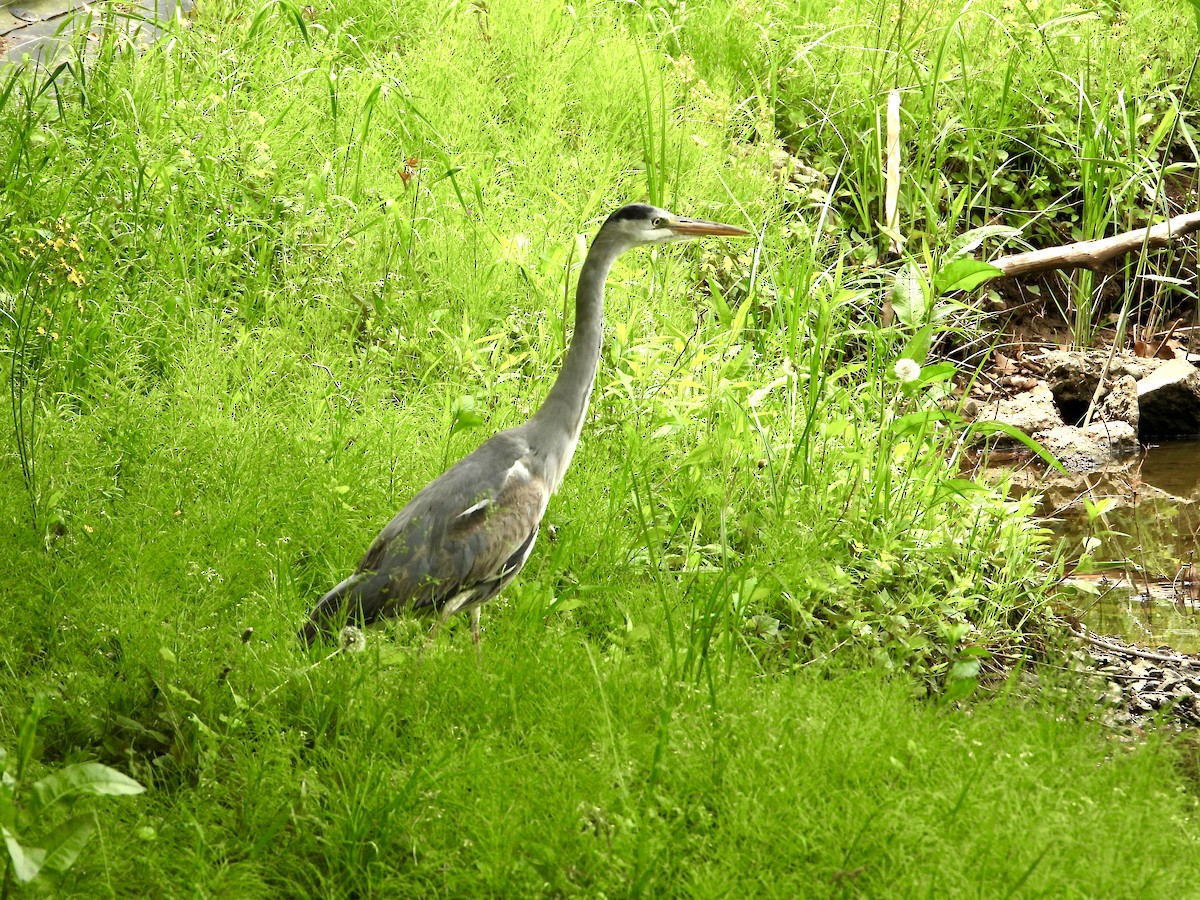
[1043,440,1200,653]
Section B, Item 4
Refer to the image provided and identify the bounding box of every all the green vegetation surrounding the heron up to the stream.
[0,0,1200,898]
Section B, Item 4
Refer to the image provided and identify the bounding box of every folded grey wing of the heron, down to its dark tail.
[305,432,550,640]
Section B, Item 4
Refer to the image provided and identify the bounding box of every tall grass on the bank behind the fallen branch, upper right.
[676,0,1198,346]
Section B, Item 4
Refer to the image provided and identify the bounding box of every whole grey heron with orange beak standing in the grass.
[300,204,745,643]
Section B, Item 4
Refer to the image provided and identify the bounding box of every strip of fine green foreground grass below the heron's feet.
[2,610,1196,898]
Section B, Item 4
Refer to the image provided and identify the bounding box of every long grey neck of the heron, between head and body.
[529,234,625,488]
